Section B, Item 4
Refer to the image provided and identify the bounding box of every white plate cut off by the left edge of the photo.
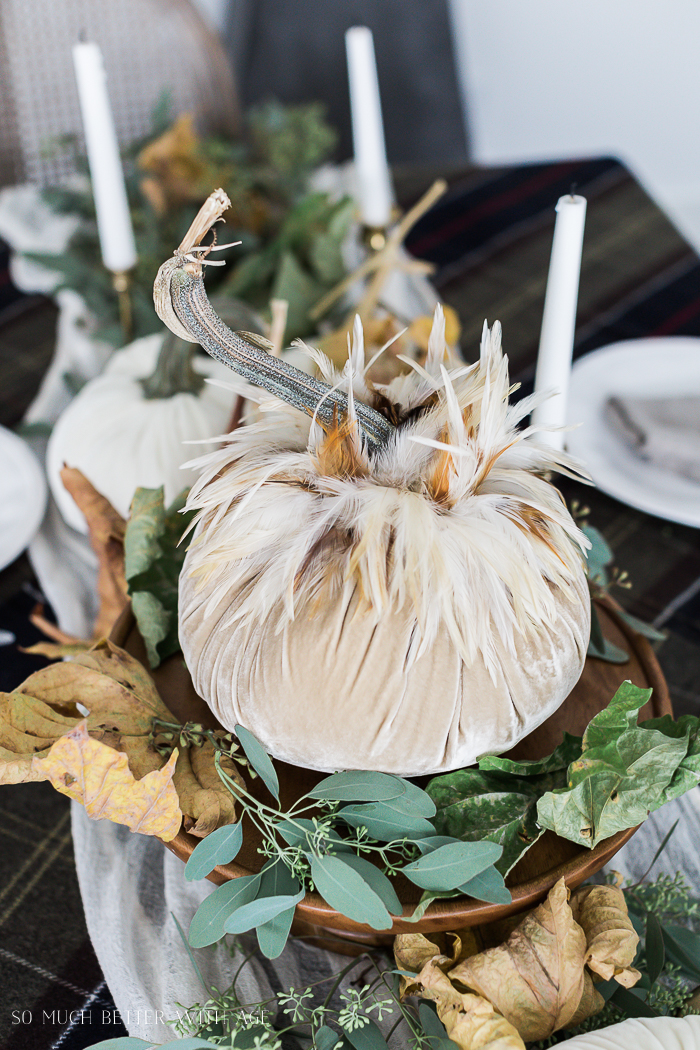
[0,426,46,569]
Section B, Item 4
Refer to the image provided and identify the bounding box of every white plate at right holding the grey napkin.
[567,336,700,526]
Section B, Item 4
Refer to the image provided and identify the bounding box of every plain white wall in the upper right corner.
[449,0,700,248]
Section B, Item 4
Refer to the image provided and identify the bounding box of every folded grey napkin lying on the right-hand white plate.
[604,395,700,484]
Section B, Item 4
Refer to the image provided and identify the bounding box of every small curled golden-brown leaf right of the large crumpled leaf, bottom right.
[571,886,641,988]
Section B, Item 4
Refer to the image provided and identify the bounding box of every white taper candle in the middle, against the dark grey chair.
[345,25,394,226]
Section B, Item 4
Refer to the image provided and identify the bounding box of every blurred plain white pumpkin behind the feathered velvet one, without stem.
[46,335,234,532]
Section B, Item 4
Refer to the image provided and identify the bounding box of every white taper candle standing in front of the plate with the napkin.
[532,193,586,448]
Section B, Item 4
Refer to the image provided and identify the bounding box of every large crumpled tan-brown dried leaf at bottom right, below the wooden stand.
[450,879,603,1042]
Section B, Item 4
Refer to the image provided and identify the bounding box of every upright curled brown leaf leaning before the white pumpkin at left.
[61,466,129,638]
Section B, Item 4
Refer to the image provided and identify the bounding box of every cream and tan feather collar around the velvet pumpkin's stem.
[182,307,588,674]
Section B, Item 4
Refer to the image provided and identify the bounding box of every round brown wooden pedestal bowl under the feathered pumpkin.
[111,600,672,953]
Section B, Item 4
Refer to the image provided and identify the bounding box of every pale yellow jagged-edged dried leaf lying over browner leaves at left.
[33,720,183,841]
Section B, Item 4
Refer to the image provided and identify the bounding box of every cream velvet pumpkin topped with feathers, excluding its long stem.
[178,308,590,776]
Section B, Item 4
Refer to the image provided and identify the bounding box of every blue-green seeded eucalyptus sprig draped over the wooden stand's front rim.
[180,726,510,959]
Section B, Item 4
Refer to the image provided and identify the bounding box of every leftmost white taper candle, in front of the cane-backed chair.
[72,43,136,273]
